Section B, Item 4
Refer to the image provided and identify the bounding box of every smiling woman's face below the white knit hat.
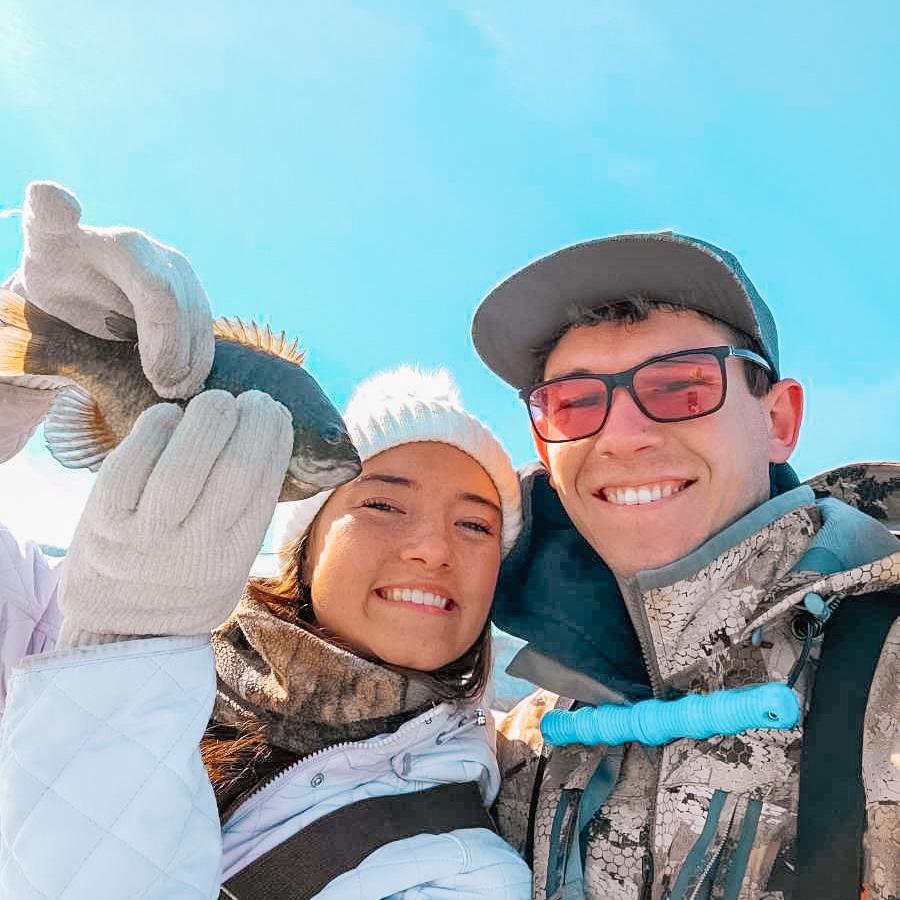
[299,442,502,671]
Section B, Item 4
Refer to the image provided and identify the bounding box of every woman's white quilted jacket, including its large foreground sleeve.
[0,528,531,900]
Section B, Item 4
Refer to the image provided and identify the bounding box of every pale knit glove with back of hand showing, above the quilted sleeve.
[59,391,292,647]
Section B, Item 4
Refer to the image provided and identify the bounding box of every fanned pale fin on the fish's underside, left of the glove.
[44,385,119,472]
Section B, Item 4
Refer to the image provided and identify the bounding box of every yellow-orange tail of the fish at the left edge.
[0,289,79,375]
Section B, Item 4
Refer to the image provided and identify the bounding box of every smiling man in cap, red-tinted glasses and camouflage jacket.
[473,233,900,900]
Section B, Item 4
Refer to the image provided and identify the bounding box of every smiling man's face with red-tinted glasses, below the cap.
[527,302,802,575]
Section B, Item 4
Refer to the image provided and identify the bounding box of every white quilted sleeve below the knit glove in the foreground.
[0,637,221,900]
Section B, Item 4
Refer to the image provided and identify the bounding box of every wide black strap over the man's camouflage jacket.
[793,591,900,900]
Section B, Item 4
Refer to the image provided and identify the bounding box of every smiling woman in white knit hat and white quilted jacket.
[0,368,531,900]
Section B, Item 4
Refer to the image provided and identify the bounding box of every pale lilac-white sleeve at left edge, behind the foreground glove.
[0,525,61,715]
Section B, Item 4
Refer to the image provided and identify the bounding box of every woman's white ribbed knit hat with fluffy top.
[273,366,522,556]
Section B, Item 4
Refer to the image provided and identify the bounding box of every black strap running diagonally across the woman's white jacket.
[219,781,496,900]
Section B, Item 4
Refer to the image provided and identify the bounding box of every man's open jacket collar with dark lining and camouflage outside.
[495,470,898,702]
